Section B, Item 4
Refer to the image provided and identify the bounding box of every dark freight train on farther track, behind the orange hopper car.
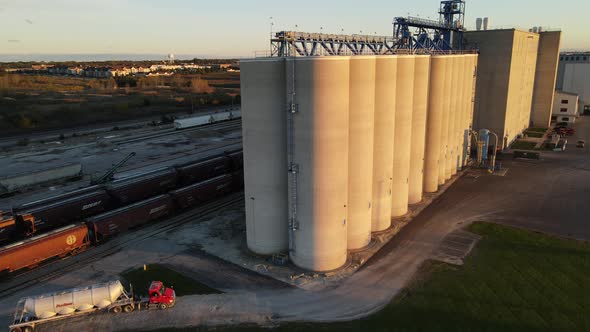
[0,150,243,243]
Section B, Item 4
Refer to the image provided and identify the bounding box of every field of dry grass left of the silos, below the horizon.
[0,72,240,136]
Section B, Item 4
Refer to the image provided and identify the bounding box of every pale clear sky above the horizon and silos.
[0,0,590,60]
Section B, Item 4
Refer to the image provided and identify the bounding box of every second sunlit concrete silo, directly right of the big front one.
[347,56,375,250]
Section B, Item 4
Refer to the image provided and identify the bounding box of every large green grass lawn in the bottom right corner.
[156,223,590,332]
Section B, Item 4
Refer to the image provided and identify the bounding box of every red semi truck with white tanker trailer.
[8,280,176,332]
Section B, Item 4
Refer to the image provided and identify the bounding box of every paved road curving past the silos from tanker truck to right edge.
[20,118,590,331]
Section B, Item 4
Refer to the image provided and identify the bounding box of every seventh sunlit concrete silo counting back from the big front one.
[438,55,455,185]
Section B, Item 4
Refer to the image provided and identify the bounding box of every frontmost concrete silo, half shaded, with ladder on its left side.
[287,56,350,271]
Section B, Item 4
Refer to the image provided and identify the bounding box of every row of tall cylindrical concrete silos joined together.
[241,55,477,271]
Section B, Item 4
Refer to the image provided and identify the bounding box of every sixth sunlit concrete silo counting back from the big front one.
[424,56,447,193]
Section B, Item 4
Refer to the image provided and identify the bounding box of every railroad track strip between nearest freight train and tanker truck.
[0,192,244,297]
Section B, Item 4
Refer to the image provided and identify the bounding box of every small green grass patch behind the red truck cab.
[121,264,221,296]
